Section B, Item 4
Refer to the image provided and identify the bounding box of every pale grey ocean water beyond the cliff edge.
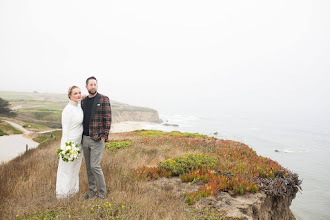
[145,114,330,220]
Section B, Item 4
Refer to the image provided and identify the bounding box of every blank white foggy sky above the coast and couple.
[0,0,330,119]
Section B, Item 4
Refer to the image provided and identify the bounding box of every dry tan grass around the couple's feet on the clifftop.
[0,133,209,219]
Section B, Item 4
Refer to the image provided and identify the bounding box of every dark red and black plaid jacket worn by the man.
[81,93,111,142]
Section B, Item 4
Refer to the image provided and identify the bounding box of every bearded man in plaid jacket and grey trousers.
[81,76,111,199]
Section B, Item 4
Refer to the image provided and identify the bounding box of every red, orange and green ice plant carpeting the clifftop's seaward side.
[136,130,301,204]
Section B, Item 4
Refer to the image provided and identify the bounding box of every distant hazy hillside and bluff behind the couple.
[0,92,159,130]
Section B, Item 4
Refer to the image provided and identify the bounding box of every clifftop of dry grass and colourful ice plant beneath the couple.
[0,130,297,219]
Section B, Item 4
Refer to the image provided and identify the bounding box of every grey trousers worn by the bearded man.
[82,135,107,195]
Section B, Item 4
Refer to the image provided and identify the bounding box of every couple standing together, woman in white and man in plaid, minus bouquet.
[56,76,111,199]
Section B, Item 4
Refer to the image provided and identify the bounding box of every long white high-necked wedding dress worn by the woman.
[56,100,84,199]
